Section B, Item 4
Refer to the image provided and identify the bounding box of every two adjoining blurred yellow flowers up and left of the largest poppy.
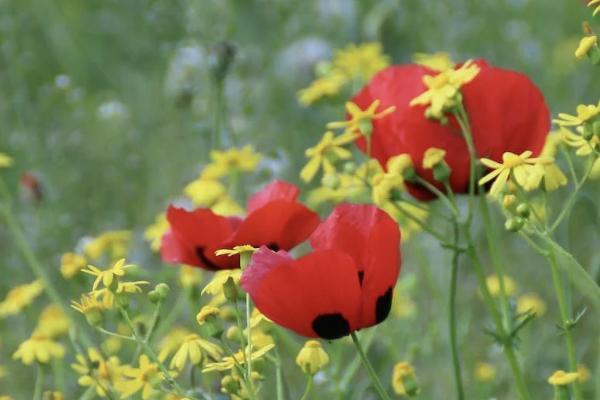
[298,42,390,106]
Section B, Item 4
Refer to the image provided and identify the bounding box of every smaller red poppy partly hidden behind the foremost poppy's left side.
[161,181,319,270]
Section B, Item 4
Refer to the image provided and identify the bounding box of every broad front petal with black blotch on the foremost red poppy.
[241,247,360,340]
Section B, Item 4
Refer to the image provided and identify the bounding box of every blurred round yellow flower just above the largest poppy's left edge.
[332,42,390,82]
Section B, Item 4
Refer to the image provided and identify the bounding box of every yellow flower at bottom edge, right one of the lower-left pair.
[116,354,165,400]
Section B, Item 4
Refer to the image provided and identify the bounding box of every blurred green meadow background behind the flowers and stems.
[0,0,600,399]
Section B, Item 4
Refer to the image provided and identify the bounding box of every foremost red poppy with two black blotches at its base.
[241,204,400,339]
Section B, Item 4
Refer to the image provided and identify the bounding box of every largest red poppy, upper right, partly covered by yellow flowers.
[352,60,550,199]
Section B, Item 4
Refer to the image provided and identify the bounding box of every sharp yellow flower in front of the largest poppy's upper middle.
[410,61,479,119]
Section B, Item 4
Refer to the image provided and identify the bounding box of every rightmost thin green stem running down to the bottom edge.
[546,248,583,400]
